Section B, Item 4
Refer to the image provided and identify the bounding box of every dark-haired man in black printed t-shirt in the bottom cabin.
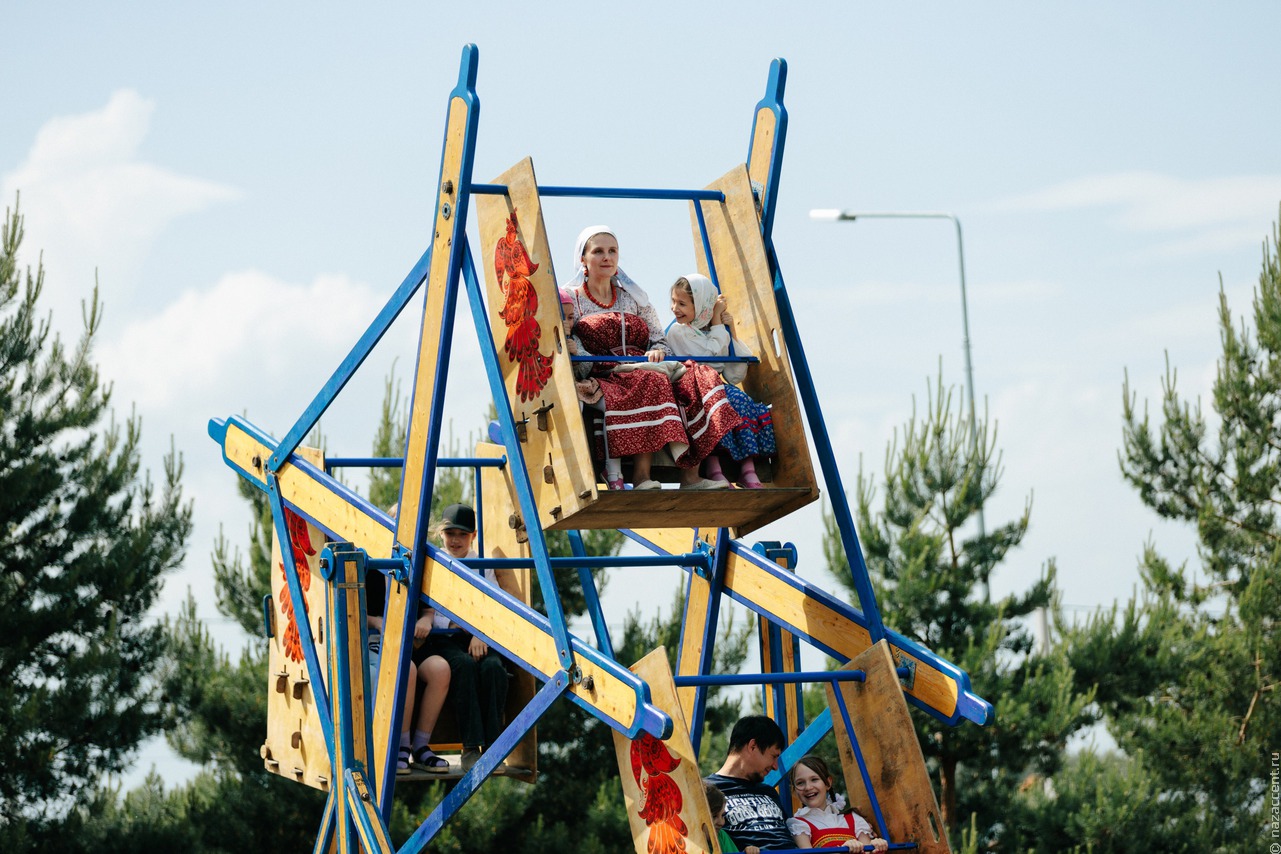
[706,714,796,851]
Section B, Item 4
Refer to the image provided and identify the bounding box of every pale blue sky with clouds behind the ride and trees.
[0,0,1281,776]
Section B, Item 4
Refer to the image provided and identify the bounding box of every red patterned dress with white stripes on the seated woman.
[573,287,742,469]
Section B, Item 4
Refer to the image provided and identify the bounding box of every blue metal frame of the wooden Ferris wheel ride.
[209,45,991,851]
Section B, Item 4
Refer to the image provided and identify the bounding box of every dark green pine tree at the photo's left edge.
[0,198,191,850]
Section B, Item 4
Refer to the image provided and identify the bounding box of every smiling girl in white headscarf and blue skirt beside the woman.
[667,273,778,489]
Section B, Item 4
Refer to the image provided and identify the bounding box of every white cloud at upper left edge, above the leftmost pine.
[0,90,241,318]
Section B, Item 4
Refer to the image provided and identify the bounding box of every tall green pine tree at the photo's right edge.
[1072,212,1281,850]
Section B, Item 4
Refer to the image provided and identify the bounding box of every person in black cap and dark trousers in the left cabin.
[428,504,509,771]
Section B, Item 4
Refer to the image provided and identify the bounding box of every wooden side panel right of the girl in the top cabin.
[690,165,819,535]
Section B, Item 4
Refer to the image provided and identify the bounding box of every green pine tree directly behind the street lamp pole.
[824,376,1090,850]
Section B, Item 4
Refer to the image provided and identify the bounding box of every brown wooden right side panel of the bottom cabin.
[828,640,951,854]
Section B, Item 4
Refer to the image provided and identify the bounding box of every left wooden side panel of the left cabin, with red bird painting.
[261,448,333,790]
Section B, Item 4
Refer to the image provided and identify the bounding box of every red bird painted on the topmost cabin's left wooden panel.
[493,209,552,401]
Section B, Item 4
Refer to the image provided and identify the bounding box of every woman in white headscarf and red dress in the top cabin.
[564,225,740,489]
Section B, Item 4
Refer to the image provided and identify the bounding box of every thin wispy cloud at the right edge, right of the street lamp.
[991,172,1281,240]
